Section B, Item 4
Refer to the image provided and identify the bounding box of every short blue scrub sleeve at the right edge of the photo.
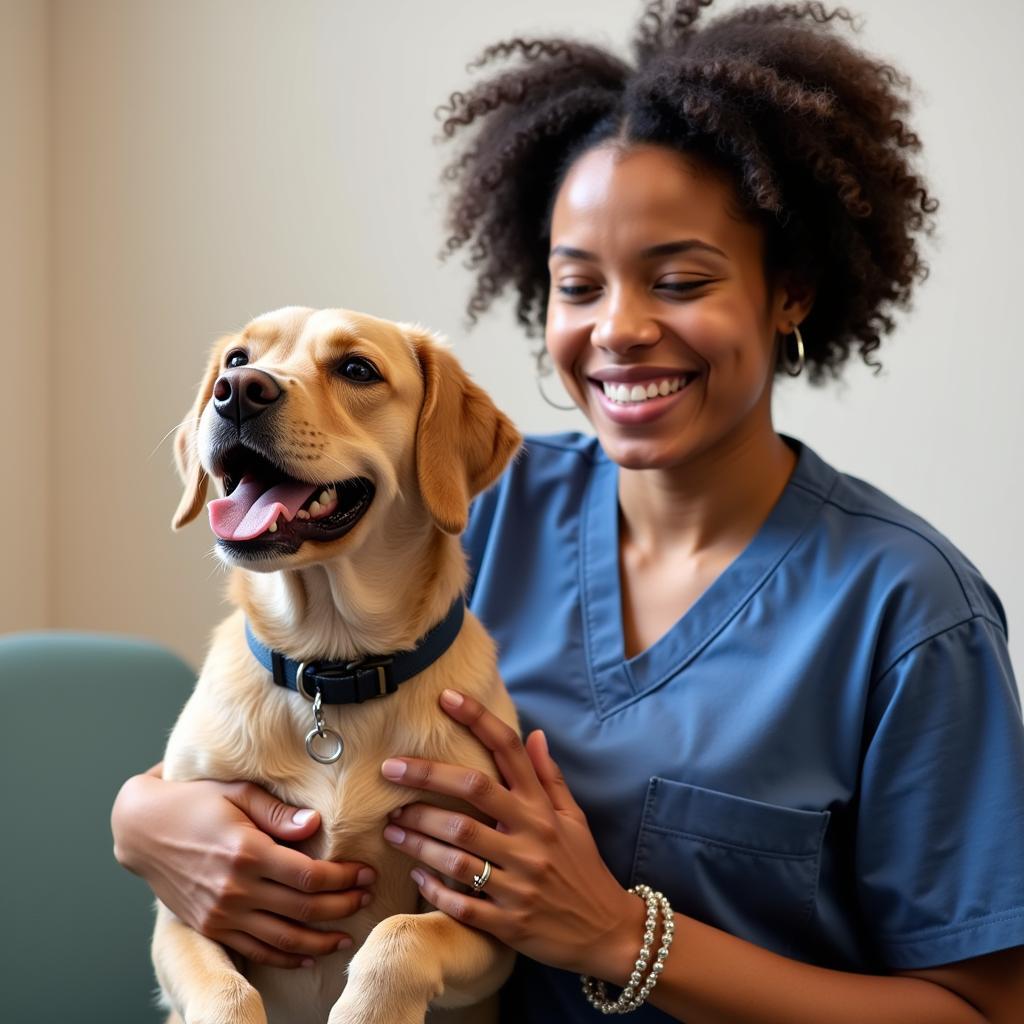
[856,616,1024,970]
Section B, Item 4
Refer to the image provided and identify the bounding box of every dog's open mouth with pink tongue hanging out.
[209,444,374,555]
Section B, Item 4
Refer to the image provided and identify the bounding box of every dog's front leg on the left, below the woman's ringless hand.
[153,903,266,1024]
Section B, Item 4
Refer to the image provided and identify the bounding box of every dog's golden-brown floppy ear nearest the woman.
[404,326,522,534]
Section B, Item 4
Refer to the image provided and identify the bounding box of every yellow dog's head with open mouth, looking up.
[172,307,521,571]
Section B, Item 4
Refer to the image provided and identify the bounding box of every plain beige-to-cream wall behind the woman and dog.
[0,0,1024,688]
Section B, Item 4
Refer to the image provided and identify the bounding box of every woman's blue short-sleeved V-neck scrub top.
[464,434,1024,1024]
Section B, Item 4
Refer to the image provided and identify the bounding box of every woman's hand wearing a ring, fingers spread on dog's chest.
[381,690,644,984]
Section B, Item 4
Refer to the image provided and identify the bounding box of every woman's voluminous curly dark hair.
[437,0,938,383]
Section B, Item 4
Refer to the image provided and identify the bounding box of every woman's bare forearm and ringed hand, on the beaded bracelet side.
[382,697,1024,1024]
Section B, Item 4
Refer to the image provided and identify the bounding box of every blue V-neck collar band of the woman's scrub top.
[580,437,838,718]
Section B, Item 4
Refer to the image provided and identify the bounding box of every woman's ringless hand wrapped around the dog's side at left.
[111,765,375,968]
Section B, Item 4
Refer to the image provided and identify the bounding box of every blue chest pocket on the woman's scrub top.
[631,776,830,954]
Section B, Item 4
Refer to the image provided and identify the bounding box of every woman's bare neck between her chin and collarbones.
[618,424,797,556]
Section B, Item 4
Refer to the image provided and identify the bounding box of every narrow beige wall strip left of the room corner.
[0,0,53,632]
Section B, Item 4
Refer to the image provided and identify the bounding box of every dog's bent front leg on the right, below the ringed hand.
[329,910,515,1024]
